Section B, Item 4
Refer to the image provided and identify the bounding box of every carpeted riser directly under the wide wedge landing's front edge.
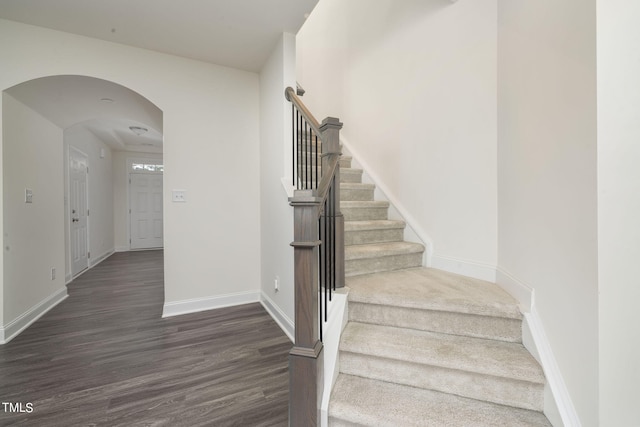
[349,301,522,343]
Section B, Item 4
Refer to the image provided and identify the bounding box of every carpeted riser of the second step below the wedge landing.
[340,351,544,411]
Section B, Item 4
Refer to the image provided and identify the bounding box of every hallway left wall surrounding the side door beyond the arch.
[64,125,114,280]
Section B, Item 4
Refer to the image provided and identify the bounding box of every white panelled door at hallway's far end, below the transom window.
[129,173,164,249]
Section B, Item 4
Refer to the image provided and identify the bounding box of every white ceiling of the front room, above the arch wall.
[0,0,318,72]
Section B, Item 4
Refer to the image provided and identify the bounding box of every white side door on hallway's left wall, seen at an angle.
[69,147,89,276]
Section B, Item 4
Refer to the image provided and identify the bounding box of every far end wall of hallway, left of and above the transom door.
[113,151,166,251]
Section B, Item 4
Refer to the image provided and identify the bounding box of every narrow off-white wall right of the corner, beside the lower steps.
[498,0,598,426]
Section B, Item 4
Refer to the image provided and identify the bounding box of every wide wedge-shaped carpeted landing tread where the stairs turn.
[346,268,522,319]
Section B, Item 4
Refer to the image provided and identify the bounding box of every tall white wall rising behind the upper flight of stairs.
[297,0,497,279]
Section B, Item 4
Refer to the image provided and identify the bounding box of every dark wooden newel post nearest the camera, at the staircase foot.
[289,196,324,427]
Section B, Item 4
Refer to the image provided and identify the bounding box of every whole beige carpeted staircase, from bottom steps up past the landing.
[329,156,551,427]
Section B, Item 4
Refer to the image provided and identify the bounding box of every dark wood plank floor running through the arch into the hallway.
[0,251,291,427]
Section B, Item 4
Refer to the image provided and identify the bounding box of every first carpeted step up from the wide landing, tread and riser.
[345,242,424,276]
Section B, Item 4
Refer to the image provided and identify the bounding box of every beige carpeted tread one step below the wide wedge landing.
[340,322,545,384]
